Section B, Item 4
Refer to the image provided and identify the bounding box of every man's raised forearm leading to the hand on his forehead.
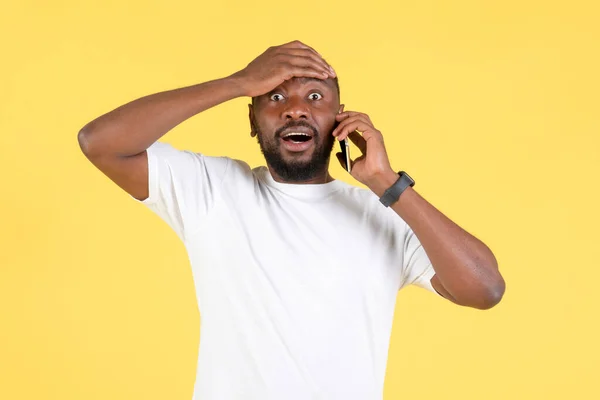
[79,77,243,157]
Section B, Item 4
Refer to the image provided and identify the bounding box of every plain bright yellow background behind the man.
[0,0,600,400]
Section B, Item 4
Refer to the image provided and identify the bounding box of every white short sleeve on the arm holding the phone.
[401,225,437,293]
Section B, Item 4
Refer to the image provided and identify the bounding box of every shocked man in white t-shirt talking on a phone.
[78,41,504,400]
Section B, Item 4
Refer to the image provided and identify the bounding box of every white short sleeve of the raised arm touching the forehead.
[134,142,230,241]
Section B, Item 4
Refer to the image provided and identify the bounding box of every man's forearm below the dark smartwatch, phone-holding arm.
[372,174,505,308]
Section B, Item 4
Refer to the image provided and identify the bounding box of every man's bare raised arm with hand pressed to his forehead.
[77,41,335,200]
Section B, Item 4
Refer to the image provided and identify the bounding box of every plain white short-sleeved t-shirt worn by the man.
[137,142,435,400]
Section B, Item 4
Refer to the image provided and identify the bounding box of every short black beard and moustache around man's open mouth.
[255,121,335,182]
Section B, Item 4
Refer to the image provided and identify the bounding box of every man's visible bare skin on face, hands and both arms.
[78,41,505,309]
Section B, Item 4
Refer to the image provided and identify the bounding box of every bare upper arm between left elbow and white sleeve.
[89,150,150,201]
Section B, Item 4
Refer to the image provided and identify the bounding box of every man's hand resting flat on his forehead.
[232,40,336,97]
